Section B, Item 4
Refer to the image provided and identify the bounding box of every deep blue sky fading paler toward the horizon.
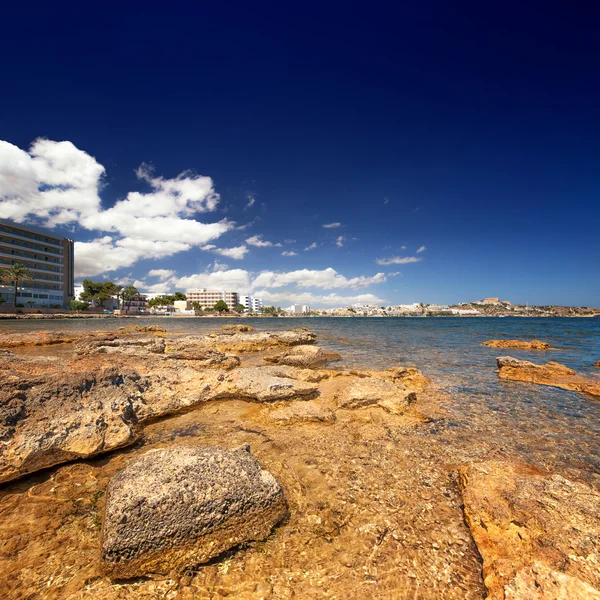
[0,2,600,306]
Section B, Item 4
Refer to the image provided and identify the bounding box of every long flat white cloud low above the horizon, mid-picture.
[252,267,386,289]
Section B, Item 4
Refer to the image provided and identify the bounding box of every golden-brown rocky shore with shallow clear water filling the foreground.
[0,324,600,600]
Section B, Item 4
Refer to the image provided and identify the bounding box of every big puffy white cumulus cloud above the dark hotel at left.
[0,139,232,276]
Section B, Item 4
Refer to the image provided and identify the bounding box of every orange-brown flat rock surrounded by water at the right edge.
[496,356,600,396]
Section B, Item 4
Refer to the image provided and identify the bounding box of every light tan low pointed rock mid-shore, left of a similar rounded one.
[213,367,319,402]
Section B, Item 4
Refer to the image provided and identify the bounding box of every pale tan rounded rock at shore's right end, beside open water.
[337,377,417,414]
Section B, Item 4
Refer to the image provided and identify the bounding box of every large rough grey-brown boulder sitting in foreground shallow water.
[102,446,287,578]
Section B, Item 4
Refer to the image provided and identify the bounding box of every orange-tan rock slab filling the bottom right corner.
[459,461,600,600]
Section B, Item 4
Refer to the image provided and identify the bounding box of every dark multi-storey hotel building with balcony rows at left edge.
[0,219,75,308]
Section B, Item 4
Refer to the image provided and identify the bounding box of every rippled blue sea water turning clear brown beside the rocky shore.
[0,317,600,484]
